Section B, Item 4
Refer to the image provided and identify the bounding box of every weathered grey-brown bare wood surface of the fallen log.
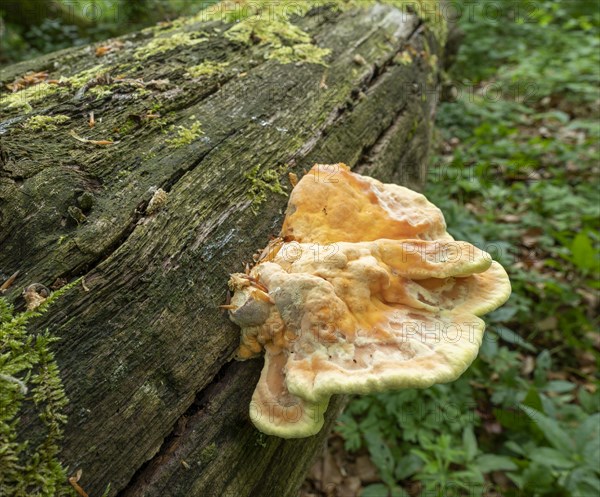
[0,4,441,497]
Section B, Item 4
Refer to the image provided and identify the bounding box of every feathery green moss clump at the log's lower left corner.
[0,280,79,497]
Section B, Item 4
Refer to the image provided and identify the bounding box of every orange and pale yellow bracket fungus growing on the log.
[225,164,511,438]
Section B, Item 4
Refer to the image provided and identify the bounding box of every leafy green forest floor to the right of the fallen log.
[300,0,600,497]
